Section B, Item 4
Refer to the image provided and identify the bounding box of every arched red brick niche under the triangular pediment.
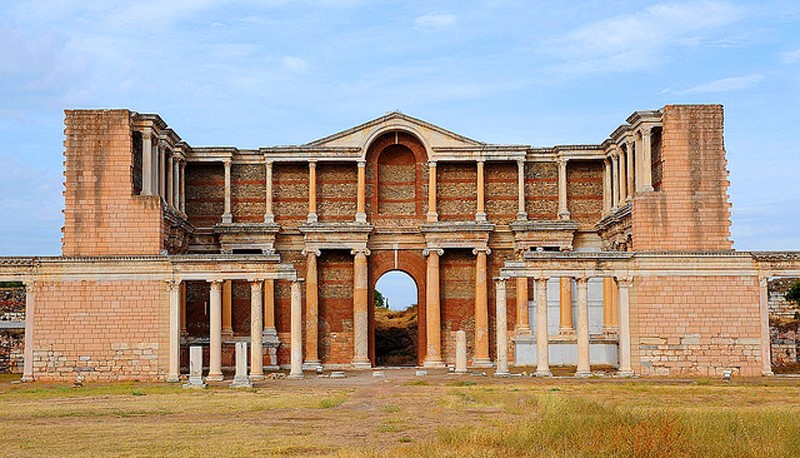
[366,131,428,223]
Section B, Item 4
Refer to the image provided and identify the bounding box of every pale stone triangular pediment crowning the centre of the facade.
[306,111,485,148]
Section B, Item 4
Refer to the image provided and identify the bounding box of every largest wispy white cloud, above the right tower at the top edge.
[545,1,745,74]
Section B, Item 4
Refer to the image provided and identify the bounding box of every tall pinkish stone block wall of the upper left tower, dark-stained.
[62,110,165,256]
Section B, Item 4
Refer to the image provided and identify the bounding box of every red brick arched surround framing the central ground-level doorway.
[369,250,427,364]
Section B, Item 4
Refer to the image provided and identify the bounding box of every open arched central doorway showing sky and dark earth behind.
[374,270,419,366]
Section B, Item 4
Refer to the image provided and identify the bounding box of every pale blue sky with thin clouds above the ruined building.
[0,0,800,266]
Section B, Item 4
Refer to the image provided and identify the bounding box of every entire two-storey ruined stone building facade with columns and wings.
[0,105,800,381]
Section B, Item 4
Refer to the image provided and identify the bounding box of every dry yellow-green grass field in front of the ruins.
[0,371,800,457]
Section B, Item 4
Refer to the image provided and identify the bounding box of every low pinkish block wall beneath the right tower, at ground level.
[631,276,761,377]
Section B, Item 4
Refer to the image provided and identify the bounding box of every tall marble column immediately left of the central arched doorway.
[352,248,372,369]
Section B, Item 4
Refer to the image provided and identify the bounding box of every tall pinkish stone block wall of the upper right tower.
[632,105,732,251]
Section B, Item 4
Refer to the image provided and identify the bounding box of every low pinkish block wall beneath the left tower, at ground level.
[33,280,169,380]
